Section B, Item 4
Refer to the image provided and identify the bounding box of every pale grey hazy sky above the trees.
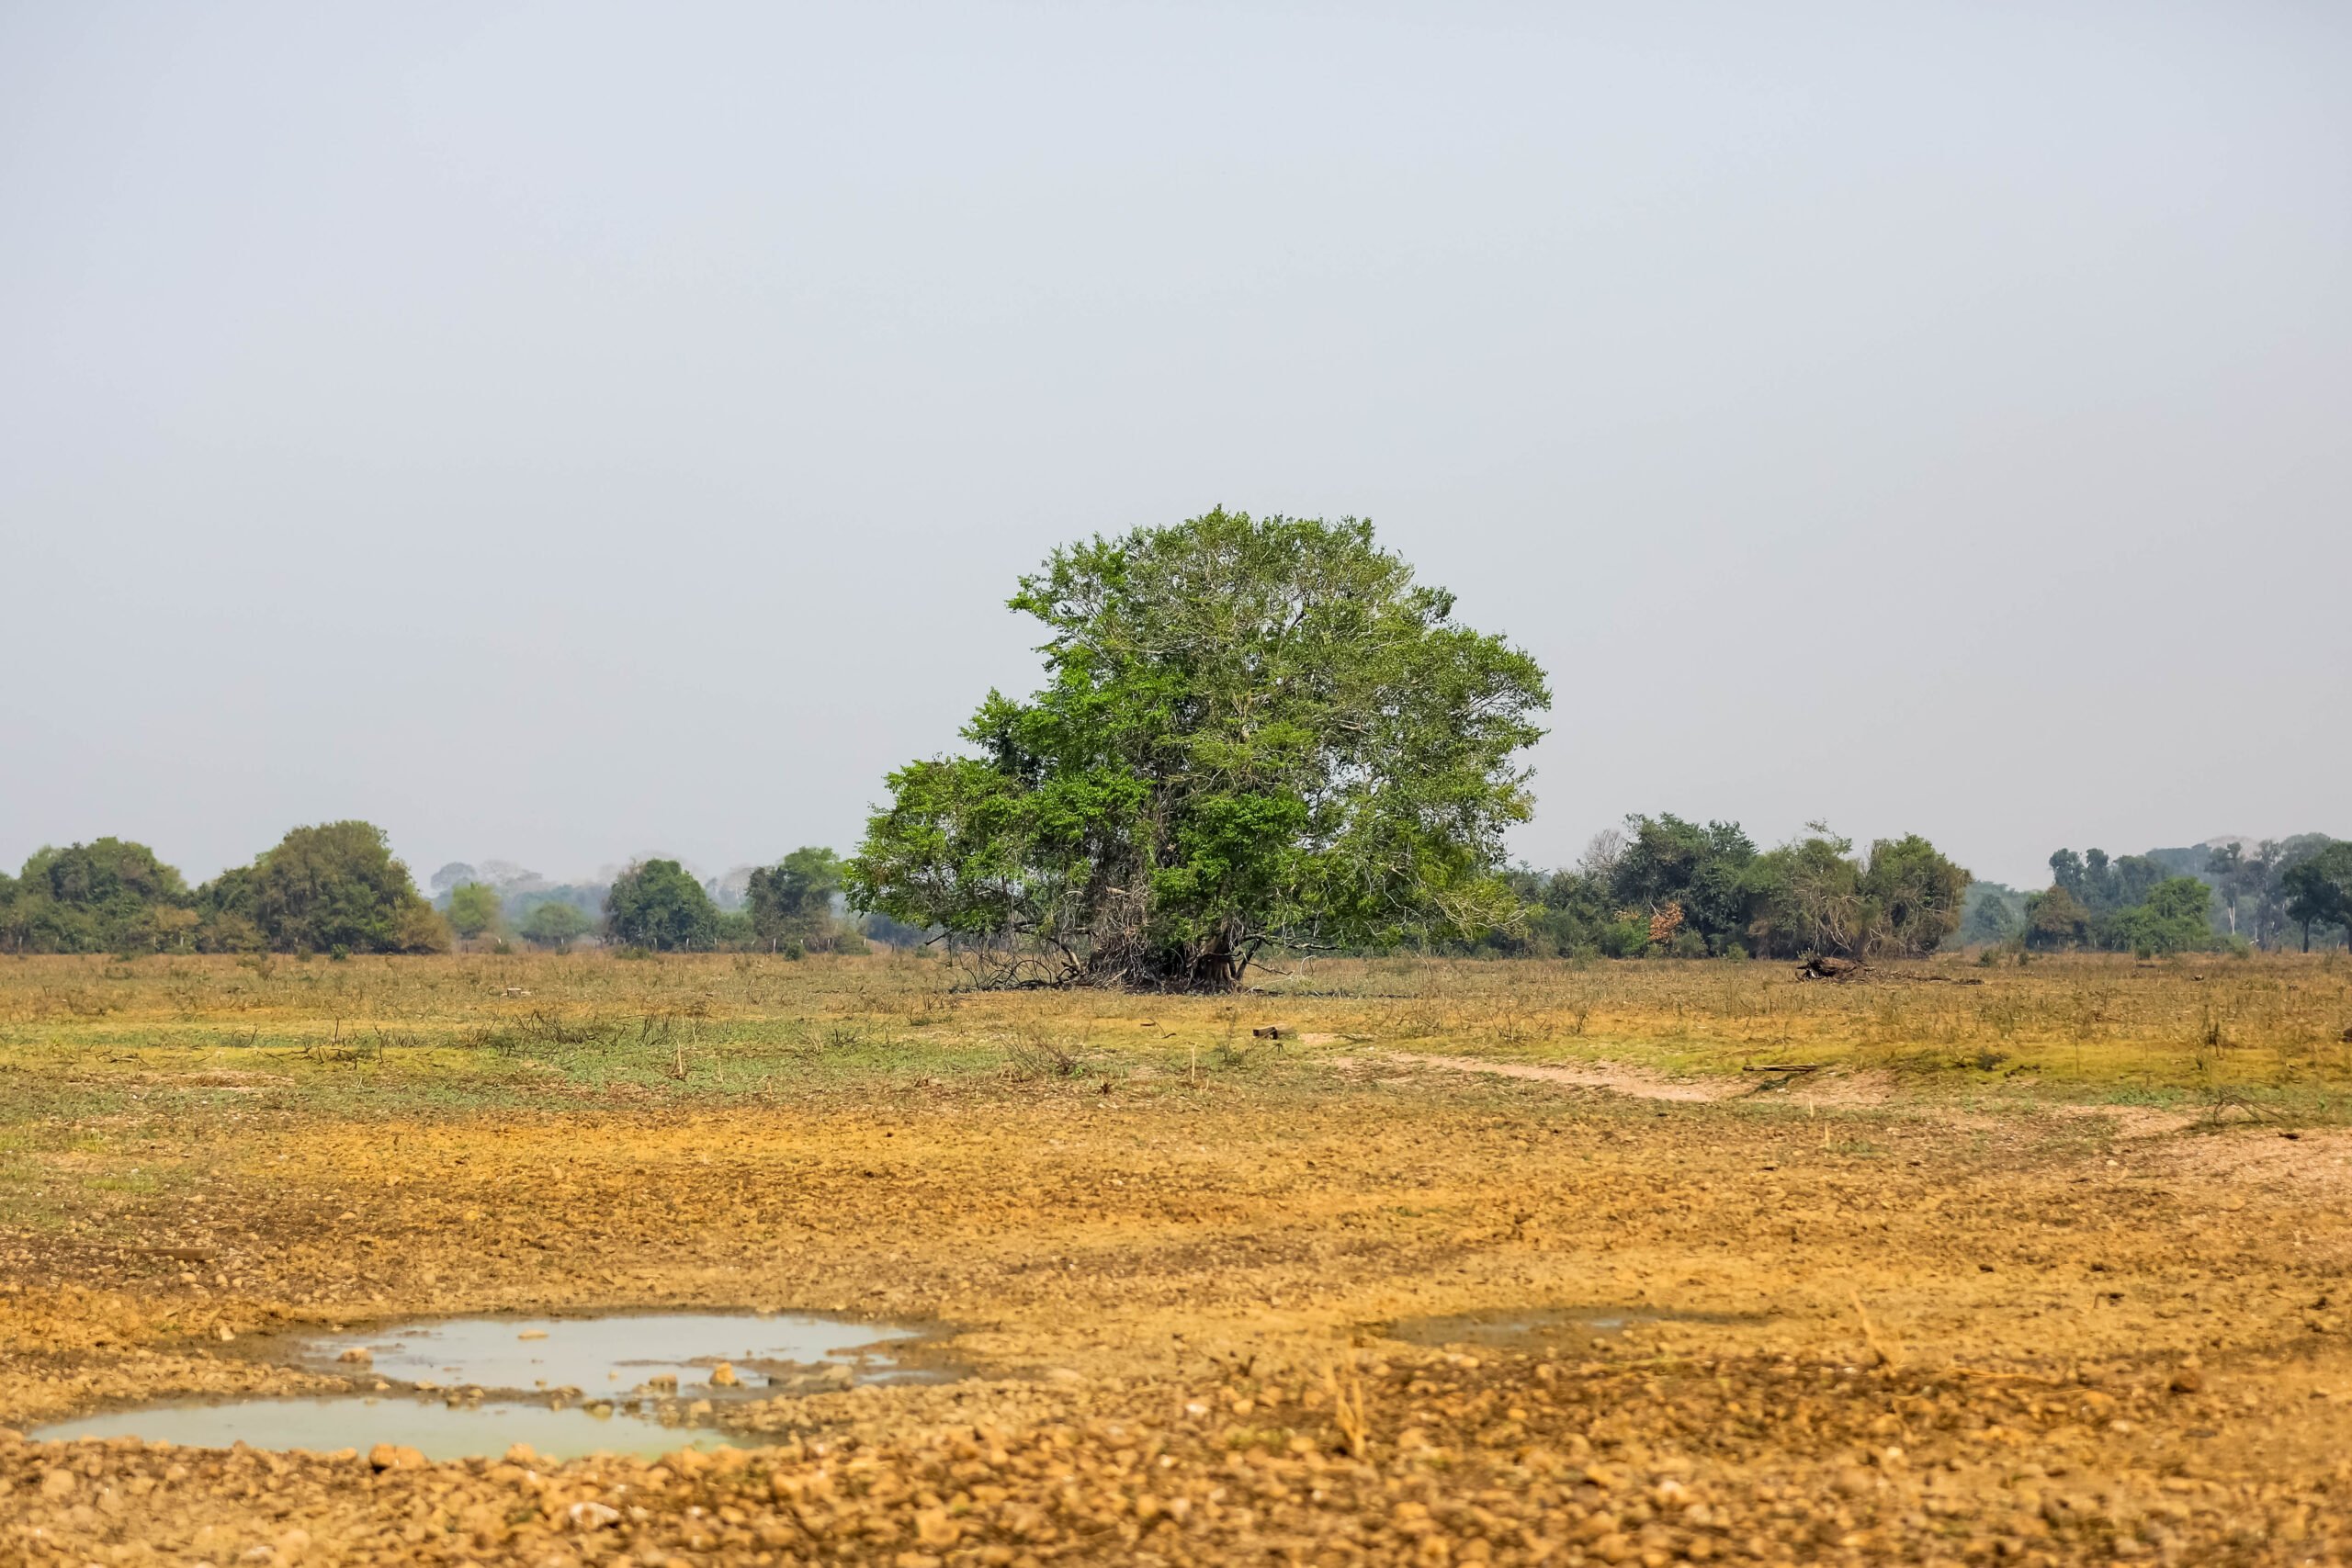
[0,0,2352,879]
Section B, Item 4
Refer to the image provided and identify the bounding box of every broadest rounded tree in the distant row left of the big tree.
[198,820,449,952]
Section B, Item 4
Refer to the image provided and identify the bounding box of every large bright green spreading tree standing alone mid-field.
[849,508,1550,987]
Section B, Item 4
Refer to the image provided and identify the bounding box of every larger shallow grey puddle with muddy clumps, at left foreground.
[33,1312,932,1460]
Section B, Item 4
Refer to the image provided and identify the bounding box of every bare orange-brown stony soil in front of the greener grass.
[0,1034,2352,1568]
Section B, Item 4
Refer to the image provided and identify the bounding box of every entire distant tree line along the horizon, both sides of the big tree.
[14,813,2352,959]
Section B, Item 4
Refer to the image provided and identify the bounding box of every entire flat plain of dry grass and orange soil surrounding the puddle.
[0,952,2352,1568]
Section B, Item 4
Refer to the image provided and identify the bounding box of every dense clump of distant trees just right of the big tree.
[1477,813,1969,959]
